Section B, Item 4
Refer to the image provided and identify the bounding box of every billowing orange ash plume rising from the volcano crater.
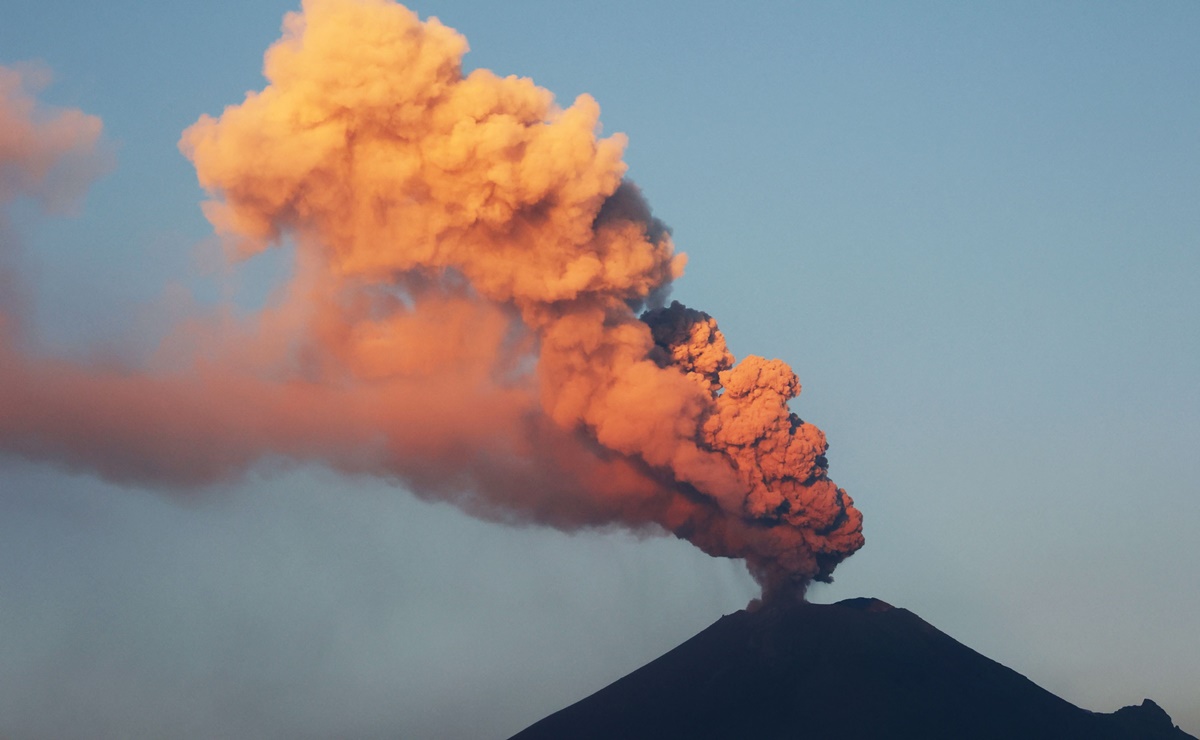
[0,0,863,592]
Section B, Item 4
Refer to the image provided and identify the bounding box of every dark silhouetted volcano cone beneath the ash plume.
[511,598,1196,740]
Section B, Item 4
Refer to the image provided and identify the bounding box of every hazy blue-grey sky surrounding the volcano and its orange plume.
[0,1,1200,738]
